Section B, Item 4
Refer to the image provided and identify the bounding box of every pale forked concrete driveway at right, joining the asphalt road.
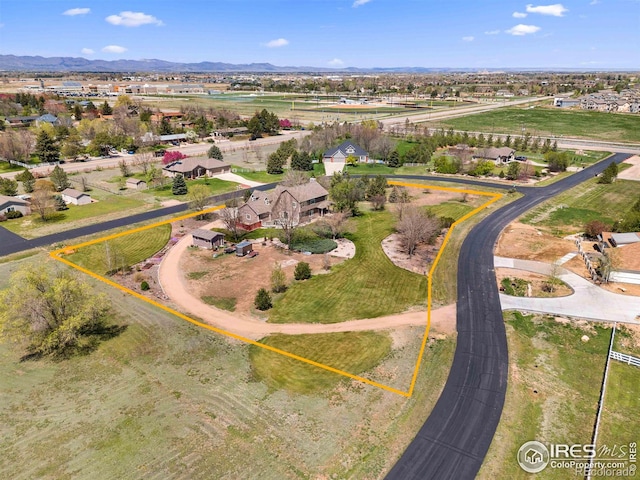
[494,257,640,324]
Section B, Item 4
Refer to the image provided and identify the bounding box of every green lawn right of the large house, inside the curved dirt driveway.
[269,212,427,323]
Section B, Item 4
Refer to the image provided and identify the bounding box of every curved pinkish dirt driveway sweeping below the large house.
[158,227,456,340]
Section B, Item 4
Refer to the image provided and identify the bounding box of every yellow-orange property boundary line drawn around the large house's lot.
[50,181,503,397]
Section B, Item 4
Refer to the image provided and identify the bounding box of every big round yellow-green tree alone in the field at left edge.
[0,264,110,356]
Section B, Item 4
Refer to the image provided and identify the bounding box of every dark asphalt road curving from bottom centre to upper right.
[387,154,629,480]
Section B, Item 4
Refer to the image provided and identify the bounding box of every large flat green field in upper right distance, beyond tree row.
[441,107,640,142]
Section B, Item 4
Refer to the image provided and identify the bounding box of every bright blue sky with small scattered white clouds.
[0,0,640,69]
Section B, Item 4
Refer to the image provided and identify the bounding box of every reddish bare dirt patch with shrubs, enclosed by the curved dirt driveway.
[180,242,344,314]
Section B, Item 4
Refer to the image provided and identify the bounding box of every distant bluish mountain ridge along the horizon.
[0,55,465,73]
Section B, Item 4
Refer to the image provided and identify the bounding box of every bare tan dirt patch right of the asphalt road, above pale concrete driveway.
[495,222,577,262]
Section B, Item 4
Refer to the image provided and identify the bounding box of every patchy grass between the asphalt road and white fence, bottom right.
[478,312,616,479]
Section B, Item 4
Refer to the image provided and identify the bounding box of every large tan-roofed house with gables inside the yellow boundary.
[238,181,329,230]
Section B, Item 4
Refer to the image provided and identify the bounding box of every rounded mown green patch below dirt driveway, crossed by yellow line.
[249,332,391,395]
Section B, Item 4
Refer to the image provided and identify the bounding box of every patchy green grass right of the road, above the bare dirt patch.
[521,178,640,236]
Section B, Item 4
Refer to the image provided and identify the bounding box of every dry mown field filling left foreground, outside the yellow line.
[0,256,454,480]
